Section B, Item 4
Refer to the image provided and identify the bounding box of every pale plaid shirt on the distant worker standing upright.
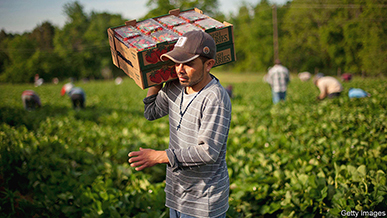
[267,64,290,92]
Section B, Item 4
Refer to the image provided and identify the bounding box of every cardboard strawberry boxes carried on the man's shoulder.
[108,8,236,89]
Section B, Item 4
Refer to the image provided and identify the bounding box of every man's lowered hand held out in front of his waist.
[128,148,169,171]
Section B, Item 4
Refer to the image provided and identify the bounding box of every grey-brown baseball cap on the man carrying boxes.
[160,30,216,64]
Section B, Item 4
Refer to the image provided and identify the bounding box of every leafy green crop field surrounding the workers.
[0,73,387,218]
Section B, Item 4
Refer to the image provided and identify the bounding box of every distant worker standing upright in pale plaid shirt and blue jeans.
[265,59,290,104]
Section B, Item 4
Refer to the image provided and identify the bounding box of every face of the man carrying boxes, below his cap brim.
[175,58,205,87]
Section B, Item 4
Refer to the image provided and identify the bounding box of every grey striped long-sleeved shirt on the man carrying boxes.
[144,76,231,217]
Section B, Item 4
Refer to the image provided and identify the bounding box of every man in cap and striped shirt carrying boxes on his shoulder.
[128,31,231,218]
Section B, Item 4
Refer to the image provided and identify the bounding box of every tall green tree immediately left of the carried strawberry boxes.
[54,2,124,79]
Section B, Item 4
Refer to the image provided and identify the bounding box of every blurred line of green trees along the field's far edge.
[0,0,387,83]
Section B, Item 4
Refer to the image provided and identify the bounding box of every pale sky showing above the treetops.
[0,0,286,34]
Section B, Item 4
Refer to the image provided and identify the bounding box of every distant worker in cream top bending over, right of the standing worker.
[313,73,343,100]
